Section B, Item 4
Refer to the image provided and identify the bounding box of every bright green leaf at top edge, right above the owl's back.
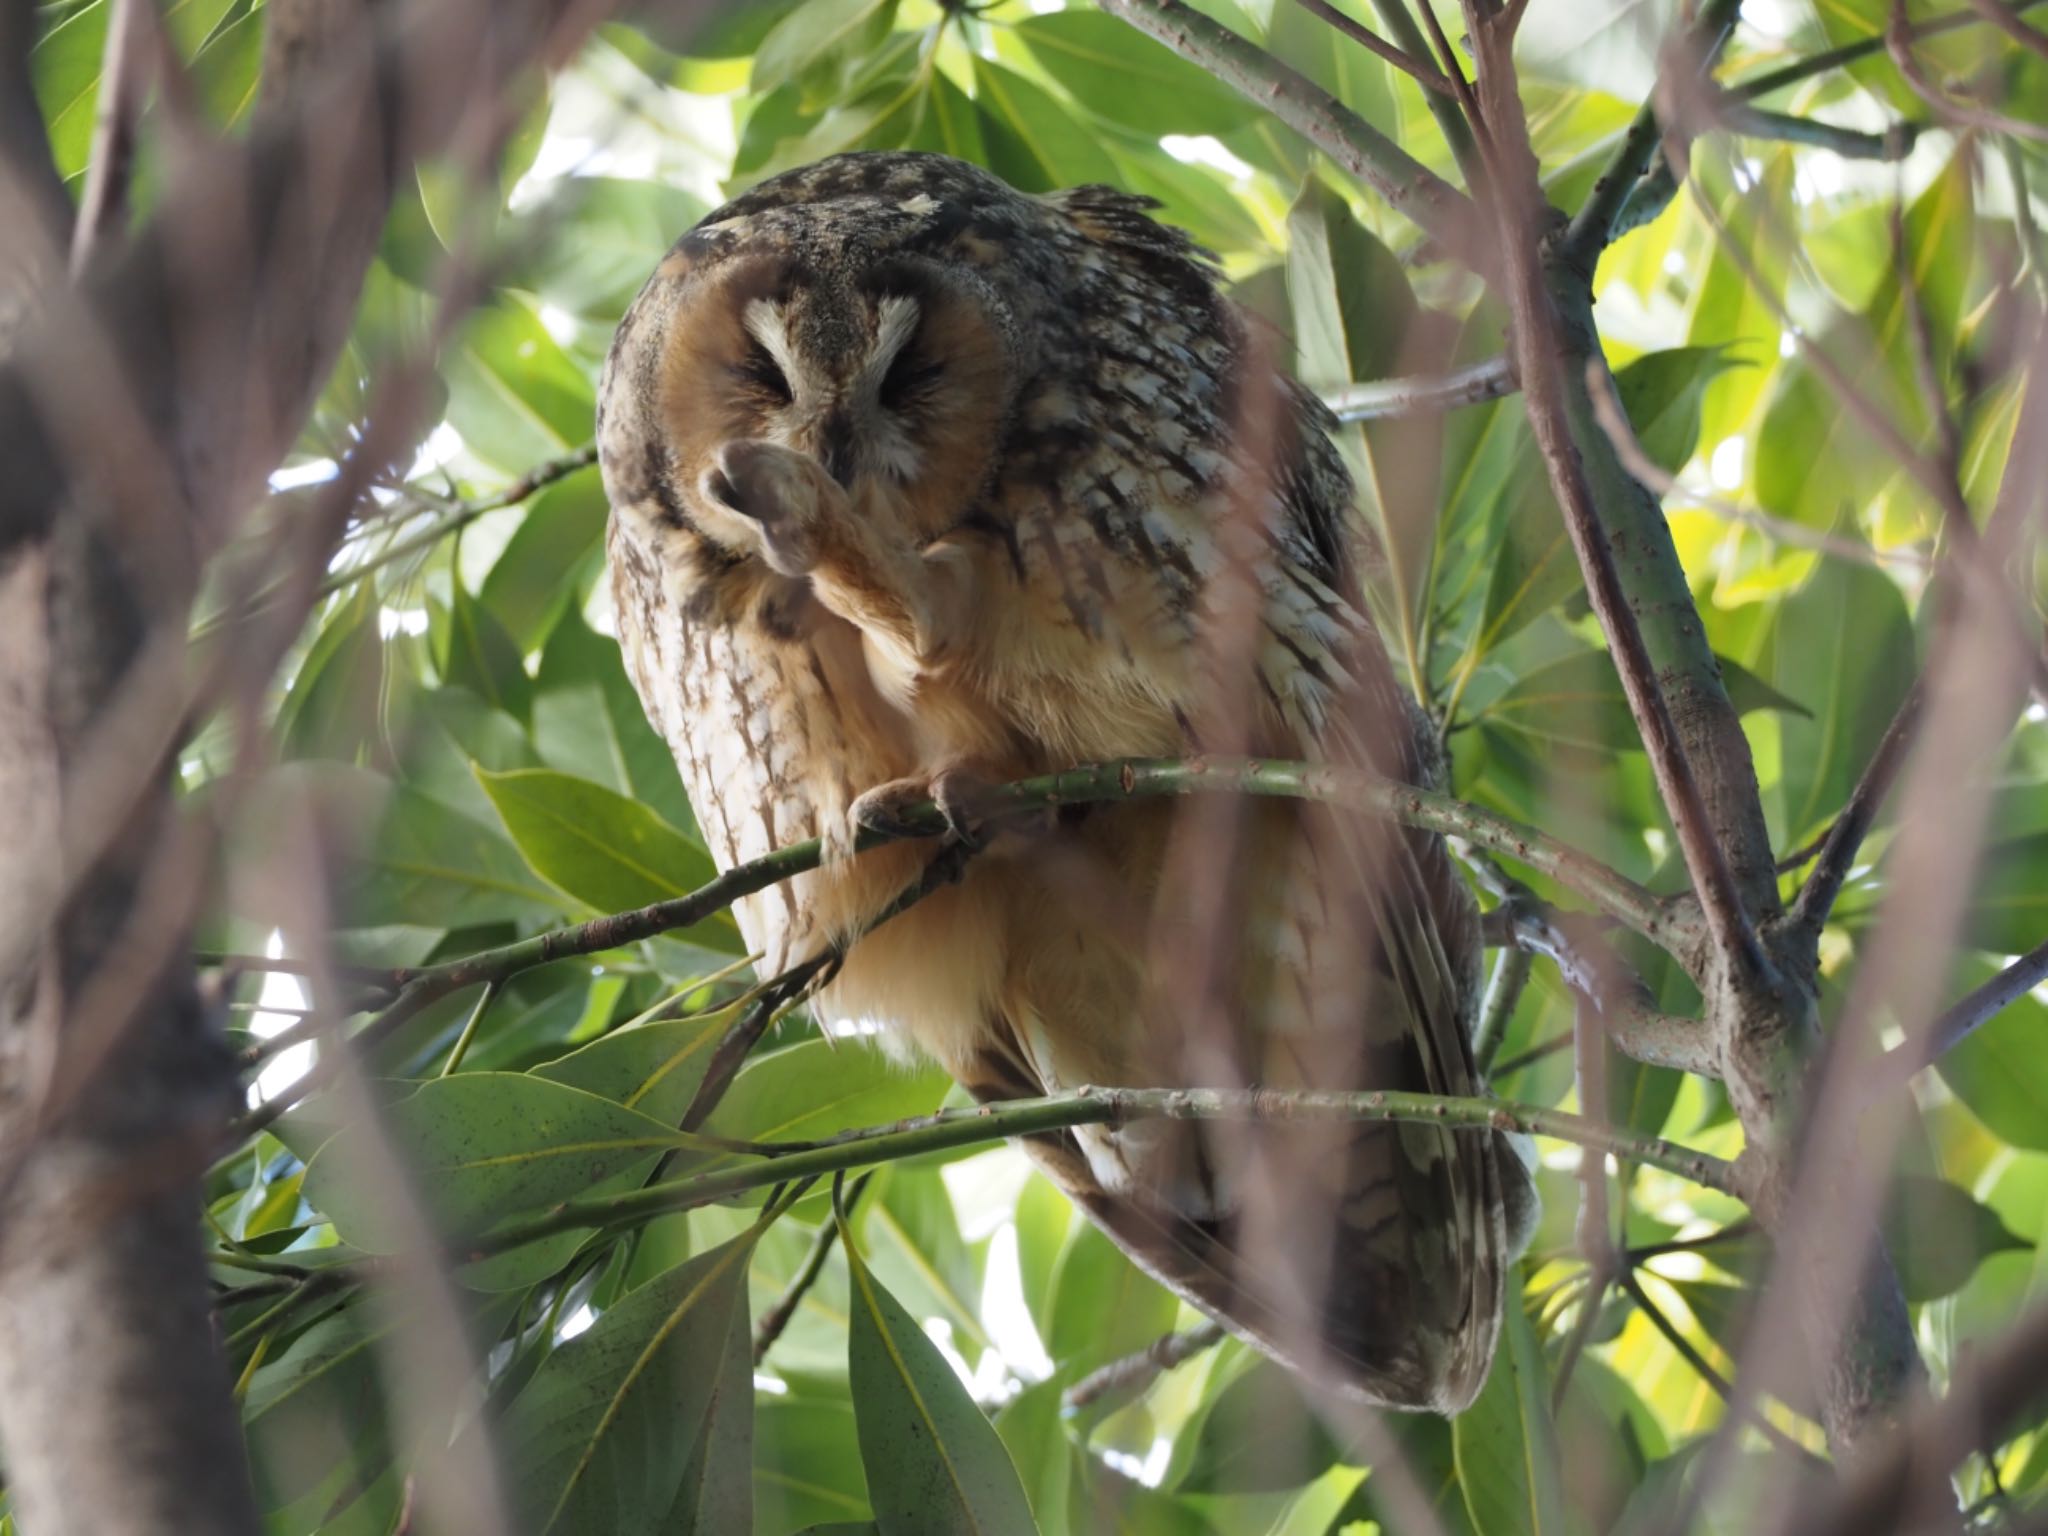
[1016,10,1257,133]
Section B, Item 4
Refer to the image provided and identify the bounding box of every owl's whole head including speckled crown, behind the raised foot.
[604,199,1018,573]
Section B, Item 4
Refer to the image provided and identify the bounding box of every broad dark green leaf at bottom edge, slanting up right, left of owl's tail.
[500,1231,756,1536]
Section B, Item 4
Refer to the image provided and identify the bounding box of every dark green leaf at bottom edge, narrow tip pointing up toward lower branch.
[846,1237,1036,1536]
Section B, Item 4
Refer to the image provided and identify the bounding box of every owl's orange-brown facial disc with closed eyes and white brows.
[657,246,1010,555]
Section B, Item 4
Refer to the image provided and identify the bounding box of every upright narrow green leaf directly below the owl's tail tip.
[1450,1296,1567,1536]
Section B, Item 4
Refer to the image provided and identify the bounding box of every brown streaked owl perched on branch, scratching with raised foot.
[598,152,1532,1411]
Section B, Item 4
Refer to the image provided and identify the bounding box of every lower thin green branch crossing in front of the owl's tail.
[479,1087,1747,1255]
